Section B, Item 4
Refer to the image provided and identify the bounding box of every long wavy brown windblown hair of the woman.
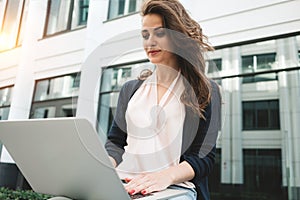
[141,0,214,119]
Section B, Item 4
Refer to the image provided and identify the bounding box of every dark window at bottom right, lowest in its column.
[240,149,288,200]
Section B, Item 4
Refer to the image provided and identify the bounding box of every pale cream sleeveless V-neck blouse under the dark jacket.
[117,71,185,178]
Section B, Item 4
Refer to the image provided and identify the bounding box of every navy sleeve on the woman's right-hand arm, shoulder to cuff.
[181,81,221,183]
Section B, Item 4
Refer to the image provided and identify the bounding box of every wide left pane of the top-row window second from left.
[46,0,71,35]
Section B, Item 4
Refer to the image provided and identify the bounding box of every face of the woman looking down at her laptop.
[142,14,177,68]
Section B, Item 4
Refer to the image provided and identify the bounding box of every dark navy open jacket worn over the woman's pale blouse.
[105,80,221,200]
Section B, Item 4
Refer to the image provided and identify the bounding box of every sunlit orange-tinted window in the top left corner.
[0,0,29,51]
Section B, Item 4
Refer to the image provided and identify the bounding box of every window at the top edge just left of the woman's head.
[108,0,143,19]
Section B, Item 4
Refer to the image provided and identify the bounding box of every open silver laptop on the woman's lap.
[0,118,185,200]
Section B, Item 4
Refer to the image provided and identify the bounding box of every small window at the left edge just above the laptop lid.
[0,86,13,120]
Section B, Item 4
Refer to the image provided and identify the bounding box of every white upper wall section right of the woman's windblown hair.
[188,0,300,45]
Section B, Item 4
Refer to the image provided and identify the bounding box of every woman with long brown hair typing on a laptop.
[105,0,220,199]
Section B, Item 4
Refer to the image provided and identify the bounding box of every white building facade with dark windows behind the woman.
[0,0,300,200]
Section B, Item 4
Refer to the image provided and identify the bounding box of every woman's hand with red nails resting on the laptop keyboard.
[125,171,172,195]
